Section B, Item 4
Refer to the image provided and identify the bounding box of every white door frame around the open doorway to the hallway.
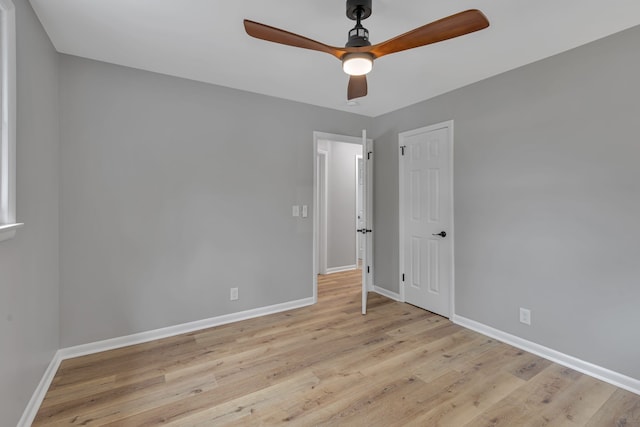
[312,131,373,304]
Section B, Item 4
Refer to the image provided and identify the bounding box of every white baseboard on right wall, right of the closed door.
[451,315,640,395]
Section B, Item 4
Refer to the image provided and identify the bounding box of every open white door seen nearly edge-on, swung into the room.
[360,129,373,314]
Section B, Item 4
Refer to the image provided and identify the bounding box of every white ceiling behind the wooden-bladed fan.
[30,0,640,117]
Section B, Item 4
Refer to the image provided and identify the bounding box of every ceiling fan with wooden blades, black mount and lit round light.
[244,0,489,100]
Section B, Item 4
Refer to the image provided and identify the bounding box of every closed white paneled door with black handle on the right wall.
[399,122,453,317]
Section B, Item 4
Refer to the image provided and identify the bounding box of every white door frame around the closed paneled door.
[398,120,456,319]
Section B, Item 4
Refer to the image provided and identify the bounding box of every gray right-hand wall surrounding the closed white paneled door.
[373,27,640,379]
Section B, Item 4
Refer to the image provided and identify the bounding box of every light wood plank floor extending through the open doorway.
[34,271,640,427]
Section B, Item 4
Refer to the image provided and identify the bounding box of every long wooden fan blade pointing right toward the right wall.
[369,9,489,58]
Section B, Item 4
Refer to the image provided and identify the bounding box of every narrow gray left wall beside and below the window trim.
[0,0,59,426]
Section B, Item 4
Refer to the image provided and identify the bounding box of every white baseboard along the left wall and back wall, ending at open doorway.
[18,298,314,427]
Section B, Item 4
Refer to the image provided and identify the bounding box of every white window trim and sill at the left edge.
[0,0,23,241]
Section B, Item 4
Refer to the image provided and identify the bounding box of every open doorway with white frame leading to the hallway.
[313,132,372,308]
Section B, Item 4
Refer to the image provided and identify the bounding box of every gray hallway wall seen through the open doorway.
[327,141,362,268]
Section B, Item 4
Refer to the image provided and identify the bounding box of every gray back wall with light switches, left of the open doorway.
[60,56,372,347]
